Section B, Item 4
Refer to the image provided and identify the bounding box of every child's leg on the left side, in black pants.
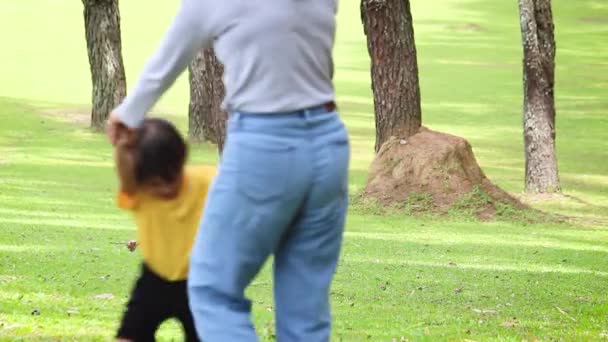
[116,265,170,342]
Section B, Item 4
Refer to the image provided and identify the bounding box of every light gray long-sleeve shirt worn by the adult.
[114,0,338,127]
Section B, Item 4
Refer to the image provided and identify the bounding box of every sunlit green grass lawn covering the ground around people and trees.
[0,0,608,341]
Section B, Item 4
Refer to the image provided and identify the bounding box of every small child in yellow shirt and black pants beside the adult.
[115,119,215,341]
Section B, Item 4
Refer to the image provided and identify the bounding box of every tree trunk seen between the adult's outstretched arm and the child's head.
[188,48,227,153]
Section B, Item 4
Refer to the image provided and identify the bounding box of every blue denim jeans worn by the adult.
[188,108,350,342]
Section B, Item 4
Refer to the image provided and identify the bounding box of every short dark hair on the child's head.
[135,118,188,183]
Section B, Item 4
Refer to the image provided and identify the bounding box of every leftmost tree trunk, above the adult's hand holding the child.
[82,0,127,129]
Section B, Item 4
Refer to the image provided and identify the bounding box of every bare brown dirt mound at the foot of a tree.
[363,128,525,218]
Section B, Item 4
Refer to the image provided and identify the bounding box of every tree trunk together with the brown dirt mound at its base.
[361,0,523,218]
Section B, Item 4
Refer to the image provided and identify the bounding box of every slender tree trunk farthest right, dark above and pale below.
[519,0,561,193]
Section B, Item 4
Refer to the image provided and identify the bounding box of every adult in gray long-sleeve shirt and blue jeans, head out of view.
[108,0,349,342]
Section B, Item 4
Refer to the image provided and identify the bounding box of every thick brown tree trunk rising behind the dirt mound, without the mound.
[361,0,421,152]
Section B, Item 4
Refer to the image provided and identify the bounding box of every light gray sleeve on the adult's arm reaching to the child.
[114,0,213,128]
